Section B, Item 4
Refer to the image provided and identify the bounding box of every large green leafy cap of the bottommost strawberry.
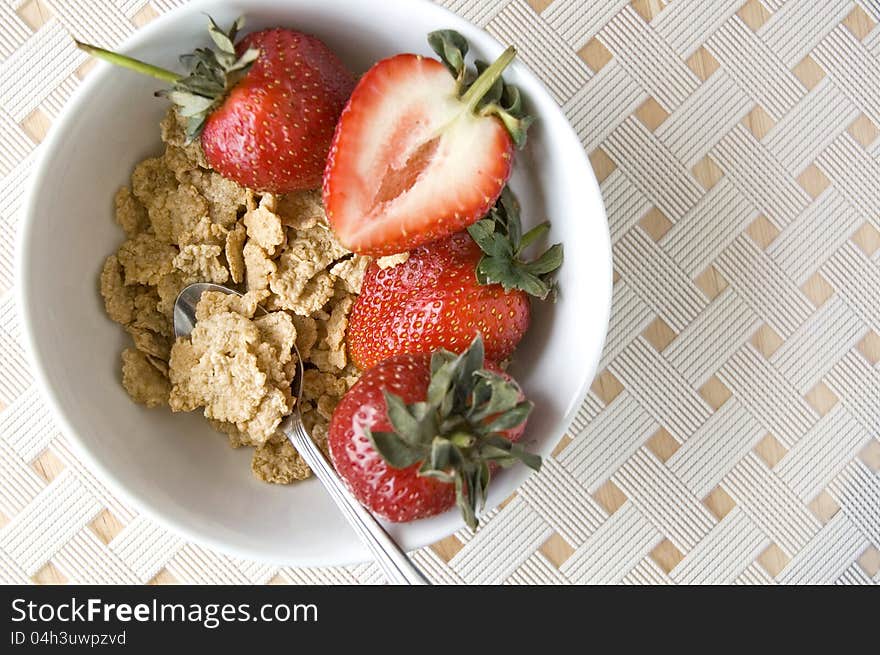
[366,334,541,530]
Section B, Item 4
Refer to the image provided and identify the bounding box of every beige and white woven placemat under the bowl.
[0,0,880,584]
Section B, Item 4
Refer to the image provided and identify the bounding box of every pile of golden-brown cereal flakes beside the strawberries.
[100,111,371,484]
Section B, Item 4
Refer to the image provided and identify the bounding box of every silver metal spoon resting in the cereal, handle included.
[174,282,431,585]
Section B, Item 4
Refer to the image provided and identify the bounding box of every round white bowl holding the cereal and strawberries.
[18,0,611,566]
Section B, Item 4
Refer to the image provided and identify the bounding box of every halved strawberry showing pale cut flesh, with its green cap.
[324,31,531,256]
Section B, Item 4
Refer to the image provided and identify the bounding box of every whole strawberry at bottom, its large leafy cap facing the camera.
[329,338,541,528]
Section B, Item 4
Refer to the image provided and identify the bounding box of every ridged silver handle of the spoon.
[281,414,431,585]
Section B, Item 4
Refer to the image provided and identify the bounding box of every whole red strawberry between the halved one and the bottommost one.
[346,190,562,369]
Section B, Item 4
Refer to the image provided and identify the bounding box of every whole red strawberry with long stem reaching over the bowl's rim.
[78,18,354,193]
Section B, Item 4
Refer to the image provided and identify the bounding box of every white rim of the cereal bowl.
[15,0,613,566]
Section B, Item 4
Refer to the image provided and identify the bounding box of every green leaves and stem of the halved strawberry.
[428,30,535,148]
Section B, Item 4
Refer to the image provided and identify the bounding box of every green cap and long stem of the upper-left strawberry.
[76,16,260,143]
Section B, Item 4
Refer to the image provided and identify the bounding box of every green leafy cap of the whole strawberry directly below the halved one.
[467,187,563,302]
